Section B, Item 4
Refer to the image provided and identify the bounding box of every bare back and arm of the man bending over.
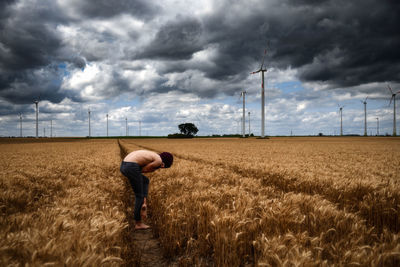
[124,150,164,172]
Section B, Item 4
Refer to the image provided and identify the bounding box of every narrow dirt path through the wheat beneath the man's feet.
[118,142,173,267]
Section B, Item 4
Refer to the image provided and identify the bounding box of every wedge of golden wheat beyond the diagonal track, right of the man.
[126,140,400,233]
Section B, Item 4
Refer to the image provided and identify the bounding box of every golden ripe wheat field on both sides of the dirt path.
[0,138,400,266]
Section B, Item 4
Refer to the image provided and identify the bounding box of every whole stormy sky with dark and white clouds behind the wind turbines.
[0,0,400,136]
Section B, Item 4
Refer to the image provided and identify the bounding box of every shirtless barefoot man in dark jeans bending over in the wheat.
[120,150,174,230]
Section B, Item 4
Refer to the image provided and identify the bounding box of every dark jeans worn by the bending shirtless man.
[120,161,149,221]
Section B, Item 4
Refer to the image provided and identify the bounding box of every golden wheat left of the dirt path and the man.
[0,140,138,266]
